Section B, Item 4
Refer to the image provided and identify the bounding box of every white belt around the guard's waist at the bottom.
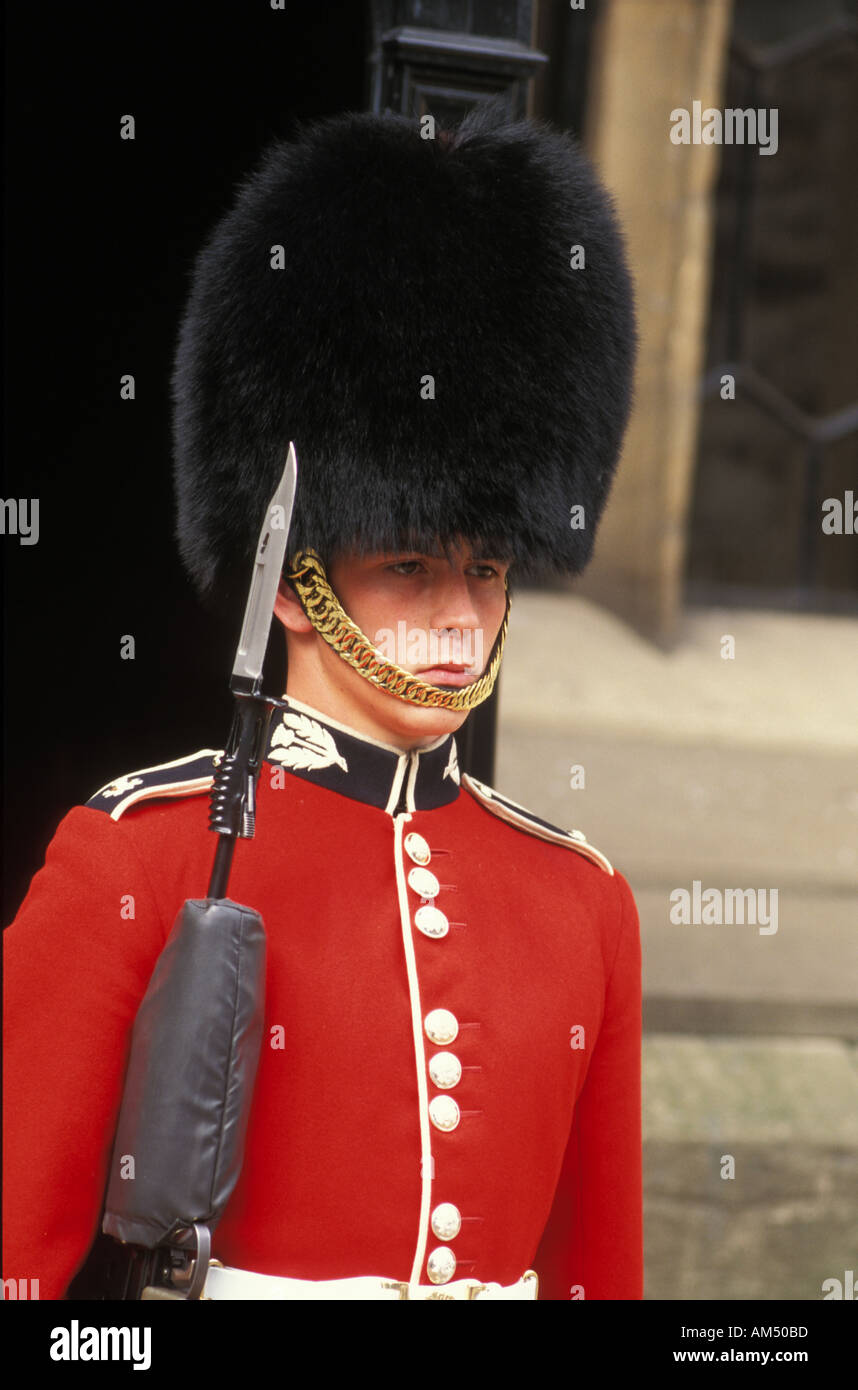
[202,1261,540,1302]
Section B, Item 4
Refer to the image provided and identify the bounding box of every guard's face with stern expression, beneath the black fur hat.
[277,545,508,746]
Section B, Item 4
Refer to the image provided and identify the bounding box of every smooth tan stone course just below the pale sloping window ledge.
[495,728,858,889]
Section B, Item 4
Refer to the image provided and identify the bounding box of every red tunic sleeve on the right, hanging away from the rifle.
[534,874,644,1300]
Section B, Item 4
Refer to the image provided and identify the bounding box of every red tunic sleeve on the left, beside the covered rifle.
[3,808,165,1298]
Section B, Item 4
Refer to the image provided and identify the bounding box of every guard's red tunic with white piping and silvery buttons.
[3,702,642,1300]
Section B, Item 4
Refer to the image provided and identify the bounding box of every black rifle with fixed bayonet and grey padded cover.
[68,445,298,1300]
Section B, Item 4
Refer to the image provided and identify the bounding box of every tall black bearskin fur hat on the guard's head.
[172,103,636,596]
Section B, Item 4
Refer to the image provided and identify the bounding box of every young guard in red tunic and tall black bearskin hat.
[4,106,642,1301]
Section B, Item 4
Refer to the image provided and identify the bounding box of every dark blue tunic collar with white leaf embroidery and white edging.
[266,698,459,816]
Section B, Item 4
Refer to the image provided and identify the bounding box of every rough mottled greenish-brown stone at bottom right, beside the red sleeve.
[642,1034,858,1301]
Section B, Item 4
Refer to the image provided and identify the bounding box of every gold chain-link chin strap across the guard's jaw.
[286,550,509,710]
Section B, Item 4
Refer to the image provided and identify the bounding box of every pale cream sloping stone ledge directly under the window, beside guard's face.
[501,591,858,756]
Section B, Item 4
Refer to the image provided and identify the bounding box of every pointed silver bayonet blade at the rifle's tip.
[229,443,298,691]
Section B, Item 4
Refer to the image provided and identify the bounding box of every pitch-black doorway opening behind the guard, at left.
[3,0,370,919]
